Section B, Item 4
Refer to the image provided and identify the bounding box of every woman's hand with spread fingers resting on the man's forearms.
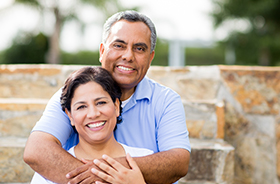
[91,154,145,184]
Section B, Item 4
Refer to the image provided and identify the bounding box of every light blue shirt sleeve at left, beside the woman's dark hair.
[32,89,73,145]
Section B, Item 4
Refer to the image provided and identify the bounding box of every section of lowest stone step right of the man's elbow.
[179,139,234,184]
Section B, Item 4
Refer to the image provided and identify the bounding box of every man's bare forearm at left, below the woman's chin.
[23,131,93,183]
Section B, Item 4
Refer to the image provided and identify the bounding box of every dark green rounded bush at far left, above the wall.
[1,33,48,64]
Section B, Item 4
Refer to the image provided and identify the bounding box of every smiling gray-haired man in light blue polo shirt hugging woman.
[24,11,190,184]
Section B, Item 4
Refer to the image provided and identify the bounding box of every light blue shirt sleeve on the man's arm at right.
[157,90,191,152]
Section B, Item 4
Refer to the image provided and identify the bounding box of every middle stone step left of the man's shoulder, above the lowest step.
[0,98,48,138]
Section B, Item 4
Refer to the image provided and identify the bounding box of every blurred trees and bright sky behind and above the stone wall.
[0,0,280,66]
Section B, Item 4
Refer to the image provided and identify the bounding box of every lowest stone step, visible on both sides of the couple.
[0,137,234,184]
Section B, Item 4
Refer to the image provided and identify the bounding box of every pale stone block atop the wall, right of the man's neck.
[147,66,221,100]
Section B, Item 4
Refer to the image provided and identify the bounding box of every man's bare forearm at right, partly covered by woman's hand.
[69,148,190,184]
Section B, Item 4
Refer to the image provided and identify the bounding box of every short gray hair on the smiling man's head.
[102,10,157,53]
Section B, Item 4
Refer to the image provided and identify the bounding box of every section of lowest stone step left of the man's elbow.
[0,137,34,183]
